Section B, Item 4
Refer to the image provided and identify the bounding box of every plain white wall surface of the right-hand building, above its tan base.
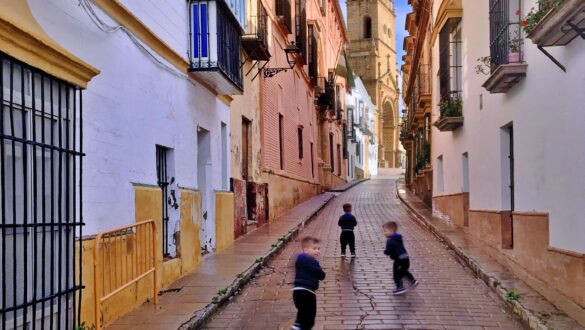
[432,0,585,253]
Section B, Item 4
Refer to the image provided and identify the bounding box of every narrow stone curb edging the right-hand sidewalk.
[396,181,551,330]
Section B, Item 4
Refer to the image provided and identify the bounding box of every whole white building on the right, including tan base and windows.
[431,0,585,322]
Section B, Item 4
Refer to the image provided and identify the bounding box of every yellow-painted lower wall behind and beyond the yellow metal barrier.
[78,186,201,327]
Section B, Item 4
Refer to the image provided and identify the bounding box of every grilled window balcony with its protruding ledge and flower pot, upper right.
[483,0,528,94]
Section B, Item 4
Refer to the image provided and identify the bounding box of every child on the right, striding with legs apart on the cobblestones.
[382,221,418,295]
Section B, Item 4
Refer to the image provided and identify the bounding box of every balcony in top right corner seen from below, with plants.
[524,0,585,47]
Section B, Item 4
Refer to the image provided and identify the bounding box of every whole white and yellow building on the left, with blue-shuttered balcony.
[0,0,245,329]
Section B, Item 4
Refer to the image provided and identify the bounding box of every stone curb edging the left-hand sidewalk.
[178,180,366,330]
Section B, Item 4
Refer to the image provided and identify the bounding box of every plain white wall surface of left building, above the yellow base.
[29,0,229,253]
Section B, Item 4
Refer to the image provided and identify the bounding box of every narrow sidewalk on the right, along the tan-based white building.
[396,180,584,330]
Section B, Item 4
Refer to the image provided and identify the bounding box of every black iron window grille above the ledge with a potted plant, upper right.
[490,0,523,71]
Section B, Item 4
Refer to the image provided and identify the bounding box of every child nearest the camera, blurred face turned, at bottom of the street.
[292,236,325,330]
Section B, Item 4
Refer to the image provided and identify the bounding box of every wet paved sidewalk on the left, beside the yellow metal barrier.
[106,181,361,330]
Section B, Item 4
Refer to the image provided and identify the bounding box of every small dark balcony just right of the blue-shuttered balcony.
[242,0,270,61]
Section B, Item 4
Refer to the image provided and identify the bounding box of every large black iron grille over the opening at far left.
[0,52,83,329]
